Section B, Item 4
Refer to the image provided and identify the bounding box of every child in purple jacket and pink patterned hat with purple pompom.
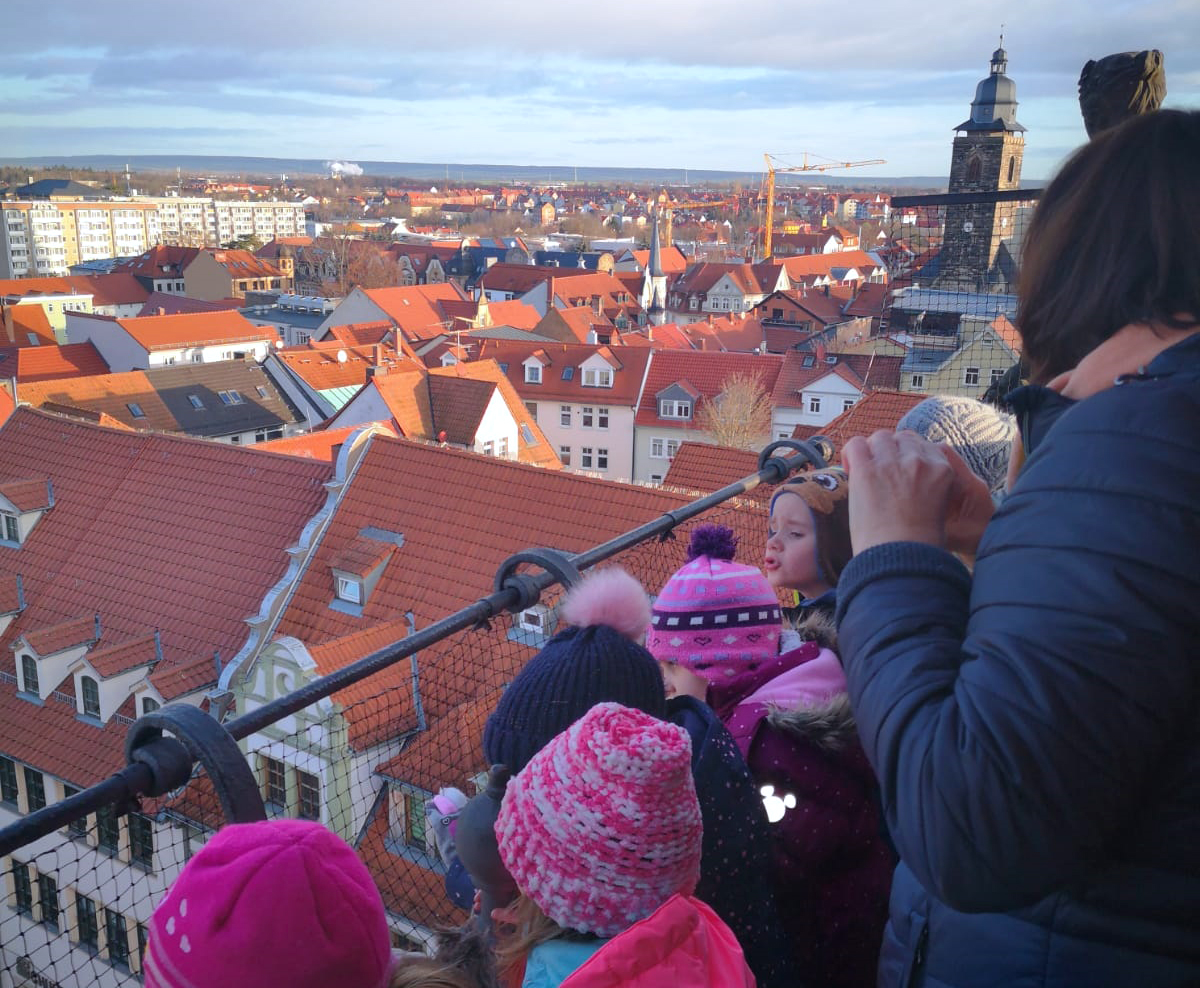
[647,521,894,988]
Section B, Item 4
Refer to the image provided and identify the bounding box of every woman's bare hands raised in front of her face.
[841,430,964,553]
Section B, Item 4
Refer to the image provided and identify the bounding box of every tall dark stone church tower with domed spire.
[934,45,1025,292]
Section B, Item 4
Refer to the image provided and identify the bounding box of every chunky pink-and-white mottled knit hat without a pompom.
[496,703,702,936]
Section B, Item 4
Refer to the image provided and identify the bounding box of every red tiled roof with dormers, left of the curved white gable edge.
[0,408,331,786]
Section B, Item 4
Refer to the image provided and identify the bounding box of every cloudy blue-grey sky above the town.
[0,0,1200,179]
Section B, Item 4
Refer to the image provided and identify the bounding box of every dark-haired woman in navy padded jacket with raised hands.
[839,110,1200,988]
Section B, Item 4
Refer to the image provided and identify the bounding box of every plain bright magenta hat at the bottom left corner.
[144,820,391,988]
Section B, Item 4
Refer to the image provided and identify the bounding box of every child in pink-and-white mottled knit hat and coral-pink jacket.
[496,703,755,988]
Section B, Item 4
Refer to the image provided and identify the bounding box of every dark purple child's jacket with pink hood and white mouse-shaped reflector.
[708,641,895,988]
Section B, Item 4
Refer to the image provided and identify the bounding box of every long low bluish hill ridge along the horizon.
[0,155,946,188]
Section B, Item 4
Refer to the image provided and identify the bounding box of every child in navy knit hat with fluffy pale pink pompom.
[457,567,796,988]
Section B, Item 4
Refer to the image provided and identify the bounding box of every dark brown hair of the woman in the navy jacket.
[1016,109,1200,383]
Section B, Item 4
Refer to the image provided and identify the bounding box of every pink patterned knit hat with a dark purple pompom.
[646,525,782,683]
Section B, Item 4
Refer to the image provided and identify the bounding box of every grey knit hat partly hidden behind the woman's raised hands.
[896,395,1016,491]
